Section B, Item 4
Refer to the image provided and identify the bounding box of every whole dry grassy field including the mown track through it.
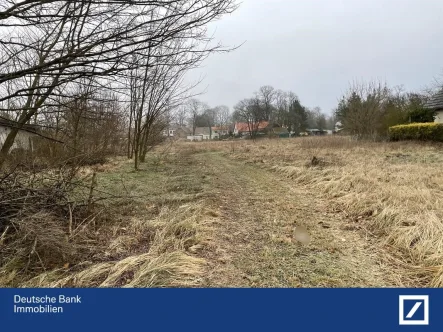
[0,137,443,287]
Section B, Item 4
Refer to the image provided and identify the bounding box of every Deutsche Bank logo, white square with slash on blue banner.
[399,295,429,325]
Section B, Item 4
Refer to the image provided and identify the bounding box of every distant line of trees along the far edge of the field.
[176,81,435,139]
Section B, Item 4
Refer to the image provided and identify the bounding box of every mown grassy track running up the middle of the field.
[194,153,395,287]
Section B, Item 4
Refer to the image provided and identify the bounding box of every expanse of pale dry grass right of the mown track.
[185,137,443,287]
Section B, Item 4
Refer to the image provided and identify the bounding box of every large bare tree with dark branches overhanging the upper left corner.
[0,0,236,167]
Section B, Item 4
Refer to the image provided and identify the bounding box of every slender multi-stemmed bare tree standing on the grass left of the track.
[129,40,199,169]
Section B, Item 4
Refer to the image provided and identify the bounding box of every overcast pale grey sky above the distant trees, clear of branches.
[190,0,443,113]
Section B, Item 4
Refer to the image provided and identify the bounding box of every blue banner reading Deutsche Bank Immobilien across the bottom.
[0,288,443,332]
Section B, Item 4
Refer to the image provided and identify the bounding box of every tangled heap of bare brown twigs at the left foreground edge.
[0,162,98,282]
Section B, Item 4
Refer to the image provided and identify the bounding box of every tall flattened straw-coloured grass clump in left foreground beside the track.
[24,205,210,287]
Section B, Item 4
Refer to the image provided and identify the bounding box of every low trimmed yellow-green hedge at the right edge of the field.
[389,122,443,142]
